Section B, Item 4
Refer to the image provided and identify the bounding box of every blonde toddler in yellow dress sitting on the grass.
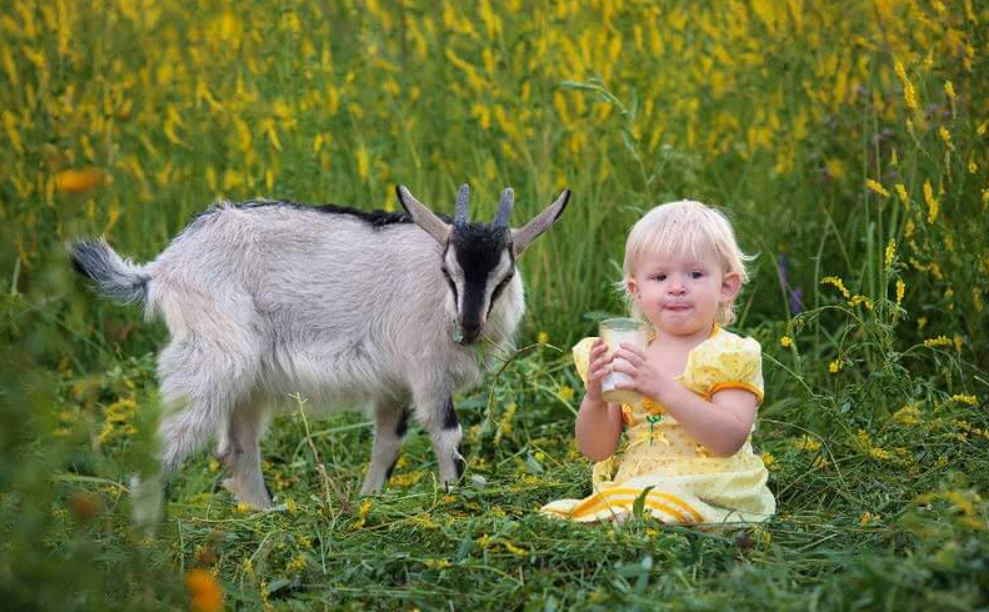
[542,201,776,524]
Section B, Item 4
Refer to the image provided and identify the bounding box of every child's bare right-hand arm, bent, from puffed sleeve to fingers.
[614,344,759,457]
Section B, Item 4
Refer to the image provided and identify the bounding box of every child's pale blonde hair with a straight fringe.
[622,200,755,325]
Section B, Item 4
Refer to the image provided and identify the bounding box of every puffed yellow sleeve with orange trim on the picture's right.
[684,336,764,403]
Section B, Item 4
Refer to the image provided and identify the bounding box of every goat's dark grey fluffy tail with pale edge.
[70,238,151,303]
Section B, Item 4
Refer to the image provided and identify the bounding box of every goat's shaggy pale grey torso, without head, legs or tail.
[148,204,462,397]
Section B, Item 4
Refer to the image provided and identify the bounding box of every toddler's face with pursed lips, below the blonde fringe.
[628,253,741,336]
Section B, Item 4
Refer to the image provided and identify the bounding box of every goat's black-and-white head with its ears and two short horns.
[396,183,570,344]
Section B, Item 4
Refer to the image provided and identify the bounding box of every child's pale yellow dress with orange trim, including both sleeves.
[540,326,776,525]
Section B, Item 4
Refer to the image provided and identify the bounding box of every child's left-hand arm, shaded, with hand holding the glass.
[574,340,622,461]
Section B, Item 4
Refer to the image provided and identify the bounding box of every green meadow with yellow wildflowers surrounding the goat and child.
[0,0,989,610]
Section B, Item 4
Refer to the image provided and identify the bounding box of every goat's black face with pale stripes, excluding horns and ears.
[444,223,515,344]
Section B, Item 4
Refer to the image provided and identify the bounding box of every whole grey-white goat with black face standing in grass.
[71,184,570,508]
